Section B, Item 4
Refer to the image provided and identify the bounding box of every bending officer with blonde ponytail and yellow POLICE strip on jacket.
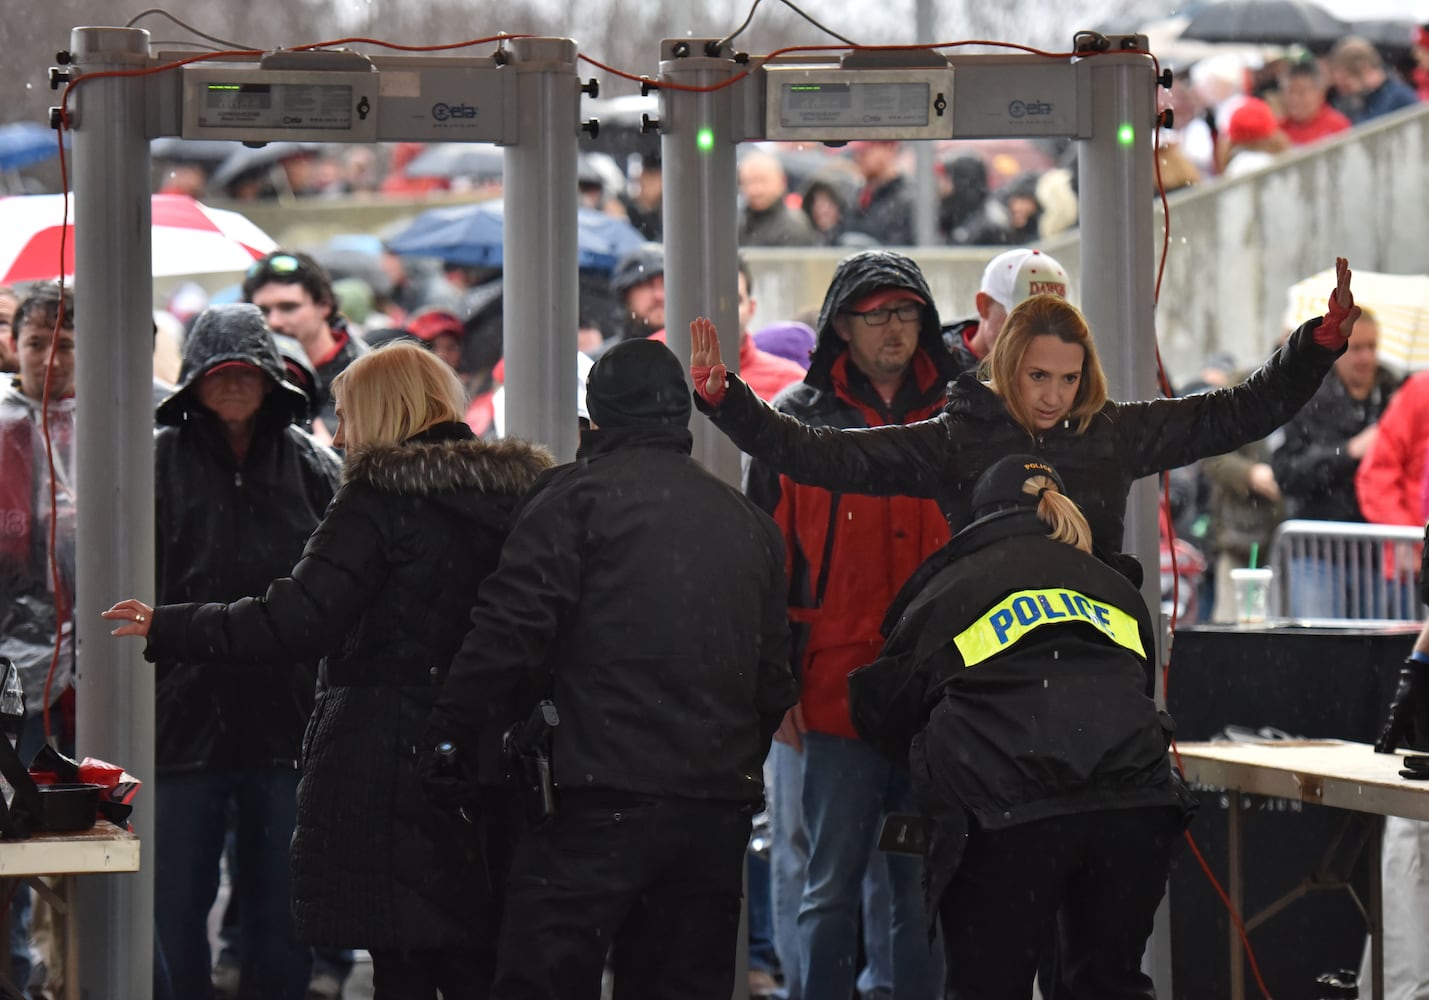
[849,454,1193,1000]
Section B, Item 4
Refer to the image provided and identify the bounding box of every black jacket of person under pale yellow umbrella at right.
[1270,362,1399,521]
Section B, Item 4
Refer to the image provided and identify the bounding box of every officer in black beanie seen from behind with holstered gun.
[426,340,797,1000]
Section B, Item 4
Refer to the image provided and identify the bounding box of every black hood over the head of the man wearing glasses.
[805,250,957,391]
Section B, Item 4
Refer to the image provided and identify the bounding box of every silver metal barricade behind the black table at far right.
[1270,520,1425,624]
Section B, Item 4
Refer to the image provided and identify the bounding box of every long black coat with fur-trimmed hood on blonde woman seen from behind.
[146,424,549,949]
